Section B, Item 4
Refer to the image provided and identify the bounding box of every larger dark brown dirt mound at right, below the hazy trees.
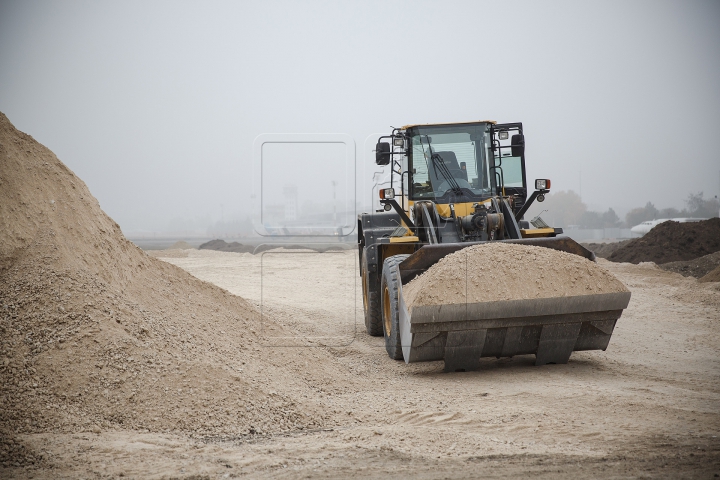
[607,218,720,265]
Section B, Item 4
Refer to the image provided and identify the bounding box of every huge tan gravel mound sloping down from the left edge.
[0,113,332,463]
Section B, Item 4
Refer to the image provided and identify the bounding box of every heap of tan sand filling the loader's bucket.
[403,243,628,308]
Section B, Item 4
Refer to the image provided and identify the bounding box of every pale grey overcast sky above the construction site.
[0,0,720,233]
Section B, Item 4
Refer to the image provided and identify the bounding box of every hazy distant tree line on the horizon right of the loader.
[525,190,720,228]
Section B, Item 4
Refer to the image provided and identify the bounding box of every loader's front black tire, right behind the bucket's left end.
[380,255,410,360]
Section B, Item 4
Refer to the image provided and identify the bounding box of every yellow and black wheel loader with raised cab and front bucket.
[358,120,630,371]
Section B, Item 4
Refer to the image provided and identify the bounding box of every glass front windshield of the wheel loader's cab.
[408,124,492,199]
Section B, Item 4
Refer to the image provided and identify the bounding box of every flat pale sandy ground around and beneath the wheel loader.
[11,250,720,478]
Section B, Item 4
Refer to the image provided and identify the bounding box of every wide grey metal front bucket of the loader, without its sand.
[396,238,630,372]
